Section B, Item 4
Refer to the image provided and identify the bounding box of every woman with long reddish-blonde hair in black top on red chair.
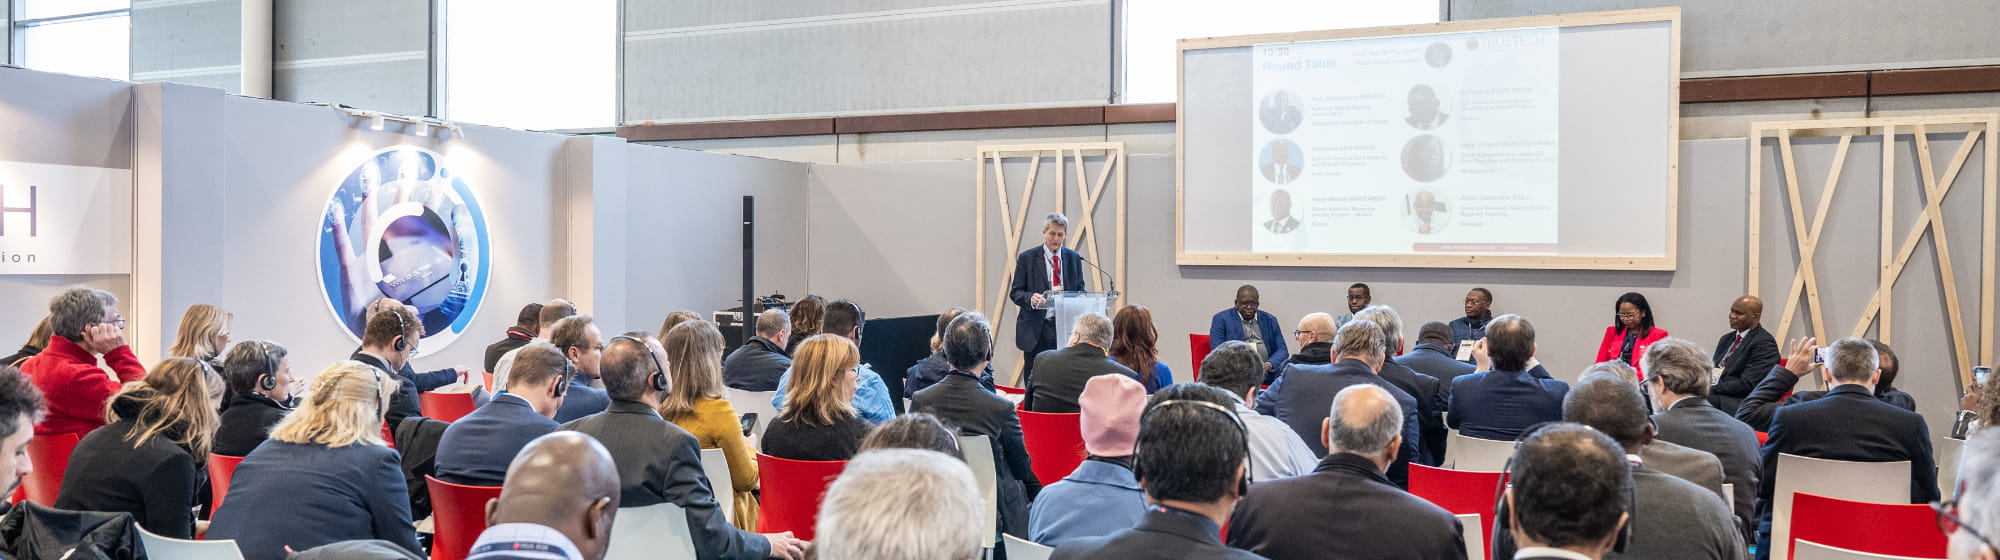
[764,334,872,460]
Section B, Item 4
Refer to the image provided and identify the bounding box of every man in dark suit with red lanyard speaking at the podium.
[1008,212,1084,386]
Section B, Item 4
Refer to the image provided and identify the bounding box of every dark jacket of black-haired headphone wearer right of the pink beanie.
[1048,510,1264,560]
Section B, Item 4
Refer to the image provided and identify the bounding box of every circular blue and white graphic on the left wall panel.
[318,146,492,352]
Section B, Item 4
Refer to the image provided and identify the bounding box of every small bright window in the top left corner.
[12,0,132,80]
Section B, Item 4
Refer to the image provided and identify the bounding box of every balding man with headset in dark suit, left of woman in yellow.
[560,334,804,560]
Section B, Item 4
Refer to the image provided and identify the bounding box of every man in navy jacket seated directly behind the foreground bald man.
[438,342,576,486]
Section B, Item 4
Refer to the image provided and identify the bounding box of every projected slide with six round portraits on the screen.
[1244,28,1562,254]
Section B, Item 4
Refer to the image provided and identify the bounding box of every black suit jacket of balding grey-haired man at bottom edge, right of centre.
[1230,452,1466,560]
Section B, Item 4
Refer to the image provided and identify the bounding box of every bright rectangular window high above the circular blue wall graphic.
[444,0,618,130]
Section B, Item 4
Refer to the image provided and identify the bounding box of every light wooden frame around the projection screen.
[1174,6,1680,270]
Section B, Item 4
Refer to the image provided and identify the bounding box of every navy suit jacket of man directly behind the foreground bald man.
[438,396,556,486]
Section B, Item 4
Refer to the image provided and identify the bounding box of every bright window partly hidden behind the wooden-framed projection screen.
[1118,0,1438,104]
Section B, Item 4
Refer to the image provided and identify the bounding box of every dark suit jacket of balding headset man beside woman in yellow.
[562,400,770,560]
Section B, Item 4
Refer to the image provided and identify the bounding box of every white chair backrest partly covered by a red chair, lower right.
[1764,454,1912,558]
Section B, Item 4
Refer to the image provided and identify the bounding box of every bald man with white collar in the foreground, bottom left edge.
[468,432,618,560]
